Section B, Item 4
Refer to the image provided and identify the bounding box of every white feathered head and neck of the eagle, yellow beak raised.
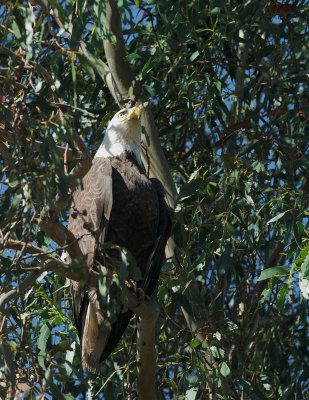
[95,106,142,165]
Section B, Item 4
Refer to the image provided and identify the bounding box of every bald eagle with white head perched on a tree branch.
[68,106,171,370]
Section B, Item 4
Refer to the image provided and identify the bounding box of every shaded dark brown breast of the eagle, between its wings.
[106,156,159,271]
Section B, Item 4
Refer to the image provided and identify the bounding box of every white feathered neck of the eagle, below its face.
[94,131,142,166]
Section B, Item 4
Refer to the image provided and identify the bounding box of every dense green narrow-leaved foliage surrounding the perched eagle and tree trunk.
[0,0,309,400]
